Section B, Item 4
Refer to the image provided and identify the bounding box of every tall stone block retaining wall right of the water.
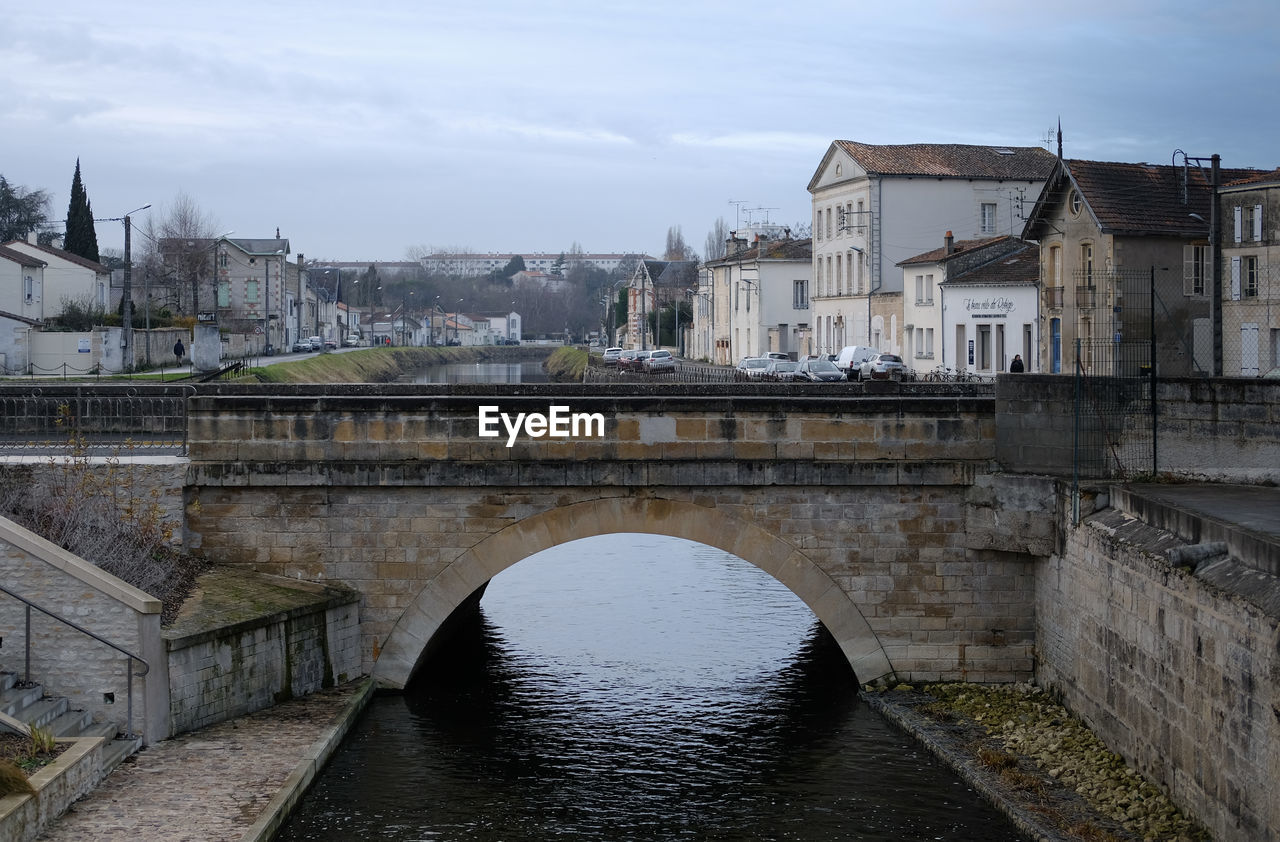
[1036,509,1280,841]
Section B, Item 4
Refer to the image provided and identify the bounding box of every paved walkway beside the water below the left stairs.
[38,682,370,842]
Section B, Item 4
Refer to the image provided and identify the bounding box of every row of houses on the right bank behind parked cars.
[660,141,1280,376]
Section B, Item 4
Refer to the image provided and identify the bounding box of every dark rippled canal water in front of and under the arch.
[278,535,1020,842]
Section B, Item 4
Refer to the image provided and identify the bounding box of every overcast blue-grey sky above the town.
[0,0,1280,260]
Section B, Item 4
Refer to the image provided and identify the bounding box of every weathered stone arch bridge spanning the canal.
[184,385,1060,687]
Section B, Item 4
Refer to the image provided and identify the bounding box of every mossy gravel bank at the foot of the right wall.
[864,683,1210,842]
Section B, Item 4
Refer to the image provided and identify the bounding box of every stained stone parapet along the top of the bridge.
[189,385,996,485]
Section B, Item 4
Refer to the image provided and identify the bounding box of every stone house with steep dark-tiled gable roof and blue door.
[1023,160,1254,376]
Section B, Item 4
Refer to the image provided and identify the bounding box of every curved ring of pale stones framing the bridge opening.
[374,496,893,688]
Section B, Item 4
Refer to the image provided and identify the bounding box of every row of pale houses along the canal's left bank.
[0,232,522,374]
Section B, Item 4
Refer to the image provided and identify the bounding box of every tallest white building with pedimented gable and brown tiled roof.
[809,141,1056,353]
